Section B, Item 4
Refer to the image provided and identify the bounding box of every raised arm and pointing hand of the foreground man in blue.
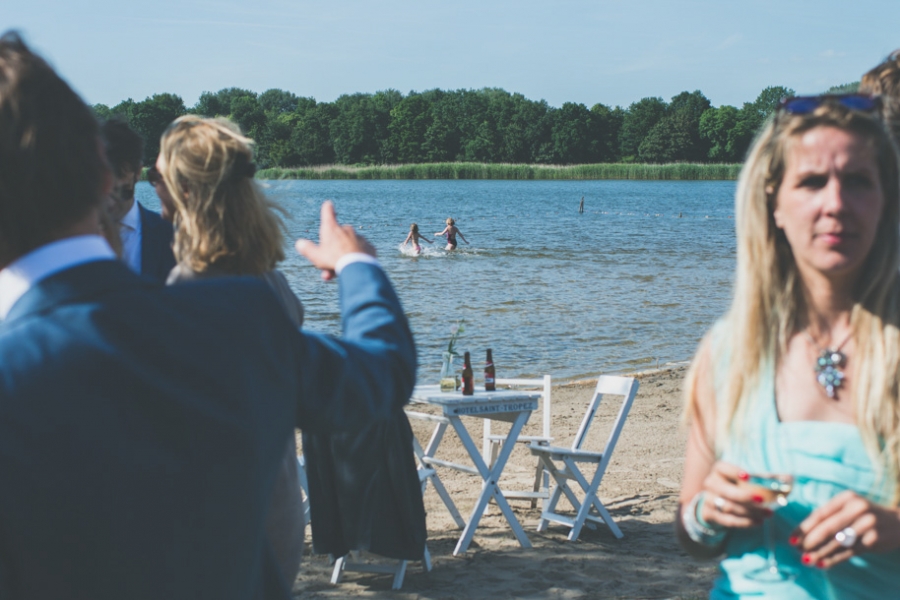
[297,202,416,431]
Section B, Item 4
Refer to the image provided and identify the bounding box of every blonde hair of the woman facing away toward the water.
[160,115,284,275]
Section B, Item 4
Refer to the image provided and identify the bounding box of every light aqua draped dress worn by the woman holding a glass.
[710,355,900,600]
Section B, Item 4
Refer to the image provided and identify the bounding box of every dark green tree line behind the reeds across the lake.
[94,84,856,167]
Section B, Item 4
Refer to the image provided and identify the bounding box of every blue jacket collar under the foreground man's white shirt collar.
[3,260,158,326]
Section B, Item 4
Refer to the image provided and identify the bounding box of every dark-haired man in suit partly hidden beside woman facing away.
[100,117,175,283]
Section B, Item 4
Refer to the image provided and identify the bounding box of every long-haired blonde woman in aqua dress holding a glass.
[676,95,900,598]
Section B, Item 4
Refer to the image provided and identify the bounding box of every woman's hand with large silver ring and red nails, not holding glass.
[789,491,900,569]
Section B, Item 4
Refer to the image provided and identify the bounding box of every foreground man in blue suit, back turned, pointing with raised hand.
[0,34,415,600]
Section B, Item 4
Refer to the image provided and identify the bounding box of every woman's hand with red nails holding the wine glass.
[700,461,772,529]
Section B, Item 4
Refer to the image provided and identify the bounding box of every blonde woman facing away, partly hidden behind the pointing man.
[148,115,304,585]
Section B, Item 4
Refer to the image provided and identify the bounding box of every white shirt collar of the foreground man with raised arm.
[0,234,116,319]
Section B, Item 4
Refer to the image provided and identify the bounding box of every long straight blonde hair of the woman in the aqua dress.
[685,102,900,503]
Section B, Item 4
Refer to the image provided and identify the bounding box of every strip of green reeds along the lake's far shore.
[256,162,741,181]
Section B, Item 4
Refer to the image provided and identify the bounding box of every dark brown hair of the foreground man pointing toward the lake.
[0,32,108,266]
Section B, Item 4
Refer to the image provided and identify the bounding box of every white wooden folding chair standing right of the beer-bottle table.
[529,375,638,540]
